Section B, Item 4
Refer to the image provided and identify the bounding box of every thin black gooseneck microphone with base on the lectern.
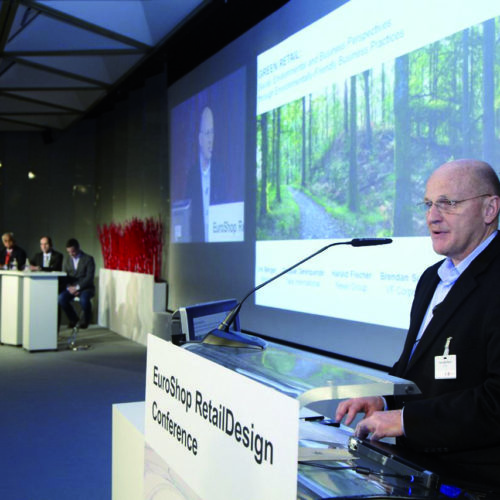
[202,238,392,349]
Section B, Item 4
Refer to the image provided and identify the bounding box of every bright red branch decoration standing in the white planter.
[97,217,163,281]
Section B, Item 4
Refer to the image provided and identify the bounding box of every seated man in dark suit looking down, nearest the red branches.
[58,238,95,328]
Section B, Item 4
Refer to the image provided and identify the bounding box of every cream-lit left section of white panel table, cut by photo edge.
[0,271,23,345]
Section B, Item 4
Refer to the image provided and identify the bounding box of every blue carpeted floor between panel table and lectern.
[0,326,146,500]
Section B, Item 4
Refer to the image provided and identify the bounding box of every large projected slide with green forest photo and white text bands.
[255,0,500,328]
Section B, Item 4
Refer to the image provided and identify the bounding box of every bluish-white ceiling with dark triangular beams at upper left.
[0,0,209,131]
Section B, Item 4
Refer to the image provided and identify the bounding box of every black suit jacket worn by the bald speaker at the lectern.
[388,235,500,485]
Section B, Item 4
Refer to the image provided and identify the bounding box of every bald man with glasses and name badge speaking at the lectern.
[336,160,500,492]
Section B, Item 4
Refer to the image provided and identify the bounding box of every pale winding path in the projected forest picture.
[288,186,344,240]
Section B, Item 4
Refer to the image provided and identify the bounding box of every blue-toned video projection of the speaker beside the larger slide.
[170,69,246,243]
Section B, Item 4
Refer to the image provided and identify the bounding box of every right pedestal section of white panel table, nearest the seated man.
[22,272,66,351]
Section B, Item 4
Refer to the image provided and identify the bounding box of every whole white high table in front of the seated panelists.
[0,271,66,351]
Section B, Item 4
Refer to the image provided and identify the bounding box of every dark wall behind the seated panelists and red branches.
[0,70,169,277]
